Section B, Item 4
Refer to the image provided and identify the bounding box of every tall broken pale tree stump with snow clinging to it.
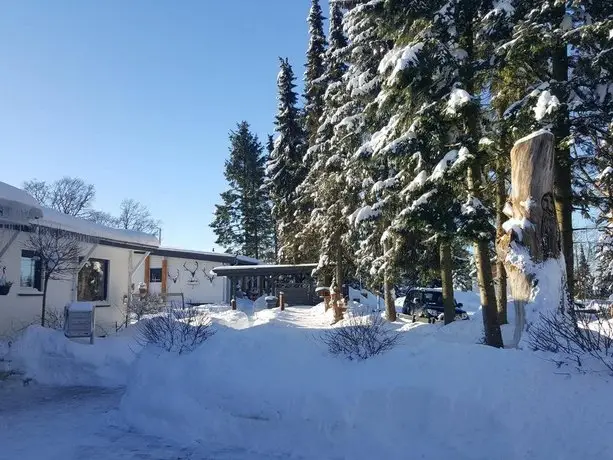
[497,131,566,347]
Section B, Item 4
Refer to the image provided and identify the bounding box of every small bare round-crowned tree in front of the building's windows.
[25,227,81,326]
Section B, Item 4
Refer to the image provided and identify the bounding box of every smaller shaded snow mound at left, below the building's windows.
[11,326,141,387]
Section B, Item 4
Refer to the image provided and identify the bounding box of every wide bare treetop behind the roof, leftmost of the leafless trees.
[23,177,96,217]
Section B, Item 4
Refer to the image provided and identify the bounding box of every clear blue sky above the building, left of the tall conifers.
[0,0,327,250]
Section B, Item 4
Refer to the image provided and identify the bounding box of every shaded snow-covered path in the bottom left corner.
[0,381,288,460]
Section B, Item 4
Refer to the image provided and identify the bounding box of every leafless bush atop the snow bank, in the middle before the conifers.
[319,313,400,360]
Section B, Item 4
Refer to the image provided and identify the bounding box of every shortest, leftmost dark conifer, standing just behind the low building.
[211,121,273,260]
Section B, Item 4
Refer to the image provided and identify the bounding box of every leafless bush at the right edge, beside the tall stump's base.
[528,311,613,372]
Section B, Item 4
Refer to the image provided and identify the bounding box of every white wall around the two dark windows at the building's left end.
[0,229,131,337]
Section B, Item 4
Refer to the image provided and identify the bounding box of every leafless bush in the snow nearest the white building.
[136,308,215,355]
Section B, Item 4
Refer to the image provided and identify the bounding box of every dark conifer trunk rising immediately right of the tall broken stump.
[552,38,575,299]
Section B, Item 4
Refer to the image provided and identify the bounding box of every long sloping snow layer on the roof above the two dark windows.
[36,207,160,247]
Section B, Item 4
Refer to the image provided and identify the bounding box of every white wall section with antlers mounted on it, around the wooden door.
[134,256,227,304]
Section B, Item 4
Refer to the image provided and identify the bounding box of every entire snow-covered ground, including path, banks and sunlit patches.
[0,293,613,460]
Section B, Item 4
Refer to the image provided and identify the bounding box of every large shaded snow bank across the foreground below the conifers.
[120,307,613,460]
